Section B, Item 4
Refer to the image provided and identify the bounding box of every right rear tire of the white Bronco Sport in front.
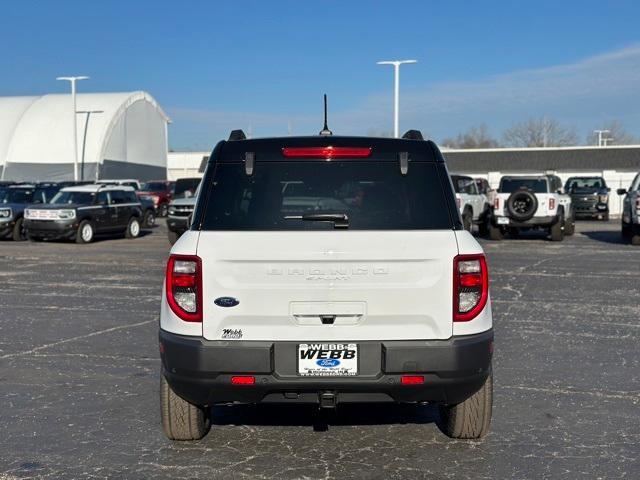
[438,373,493,439]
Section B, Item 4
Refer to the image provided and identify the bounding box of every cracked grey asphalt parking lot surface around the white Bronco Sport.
[0,220,640,480]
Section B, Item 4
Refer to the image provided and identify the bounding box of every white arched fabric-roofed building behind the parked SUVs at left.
[0,92,169,181]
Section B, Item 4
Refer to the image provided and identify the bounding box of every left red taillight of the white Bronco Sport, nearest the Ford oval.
[165,255,202,322]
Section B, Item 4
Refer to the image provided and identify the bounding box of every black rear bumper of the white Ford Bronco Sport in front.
[160,330,493,405]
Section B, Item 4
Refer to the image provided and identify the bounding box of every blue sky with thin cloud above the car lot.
[0,0,640,150]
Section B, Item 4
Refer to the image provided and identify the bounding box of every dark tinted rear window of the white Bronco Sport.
[201,160,452,230]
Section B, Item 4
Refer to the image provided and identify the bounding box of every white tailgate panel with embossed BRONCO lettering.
[197,230,458,341]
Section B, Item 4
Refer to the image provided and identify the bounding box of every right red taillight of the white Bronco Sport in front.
[453,254,489,322]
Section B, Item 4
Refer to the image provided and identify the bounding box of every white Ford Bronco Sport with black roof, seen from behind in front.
[160,131,493,440]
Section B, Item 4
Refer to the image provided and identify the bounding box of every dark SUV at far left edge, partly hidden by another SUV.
[0,183,60,241]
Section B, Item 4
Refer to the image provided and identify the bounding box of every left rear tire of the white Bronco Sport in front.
[160,375,211,440]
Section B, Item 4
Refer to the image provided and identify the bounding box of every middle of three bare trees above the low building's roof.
[503,117,578,147]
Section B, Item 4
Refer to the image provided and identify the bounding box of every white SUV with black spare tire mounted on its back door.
[489,175,575,242]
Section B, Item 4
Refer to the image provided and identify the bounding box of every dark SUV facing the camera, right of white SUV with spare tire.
[564,177,611,222]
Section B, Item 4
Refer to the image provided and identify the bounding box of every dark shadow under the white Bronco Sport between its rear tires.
[211,403,439,432]
